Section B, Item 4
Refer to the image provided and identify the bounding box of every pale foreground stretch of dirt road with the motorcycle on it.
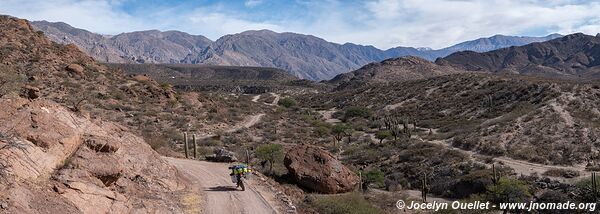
[165,157,282,214]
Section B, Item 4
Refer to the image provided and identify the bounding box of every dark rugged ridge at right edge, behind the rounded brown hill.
[436,33,600,78]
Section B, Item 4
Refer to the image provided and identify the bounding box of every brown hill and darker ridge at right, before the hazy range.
[329,33,600,88]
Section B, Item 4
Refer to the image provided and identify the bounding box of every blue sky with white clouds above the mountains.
[0,0,600,49]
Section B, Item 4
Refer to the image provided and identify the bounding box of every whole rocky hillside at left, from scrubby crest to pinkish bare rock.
[0,16,199,213]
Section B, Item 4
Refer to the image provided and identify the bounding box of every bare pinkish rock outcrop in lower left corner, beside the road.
[0,99,185,213]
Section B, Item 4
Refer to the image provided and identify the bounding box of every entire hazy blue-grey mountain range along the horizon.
[32,21,561,80]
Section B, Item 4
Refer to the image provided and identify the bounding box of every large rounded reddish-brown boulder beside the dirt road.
[284,145,359,194]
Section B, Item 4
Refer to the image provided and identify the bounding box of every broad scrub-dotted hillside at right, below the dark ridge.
[310,73,600,165]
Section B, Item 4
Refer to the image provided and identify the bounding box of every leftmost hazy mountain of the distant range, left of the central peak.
[32,21,212,63]
